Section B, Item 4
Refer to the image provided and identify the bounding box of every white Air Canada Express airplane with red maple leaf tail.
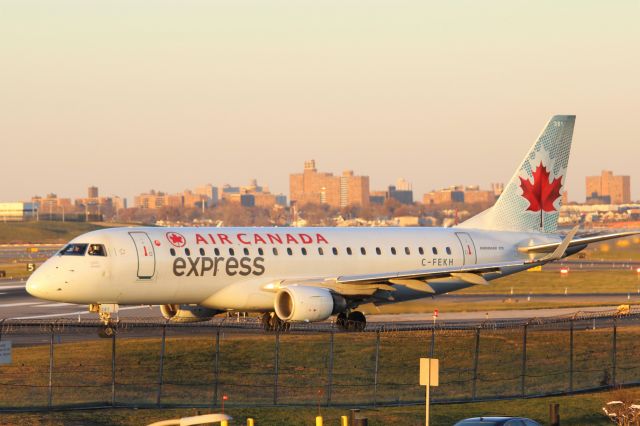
[26,115,636,336]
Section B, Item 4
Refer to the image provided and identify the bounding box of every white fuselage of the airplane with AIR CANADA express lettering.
[27,227,560,311]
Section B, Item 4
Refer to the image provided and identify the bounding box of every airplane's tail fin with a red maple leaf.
[459,115,576,232]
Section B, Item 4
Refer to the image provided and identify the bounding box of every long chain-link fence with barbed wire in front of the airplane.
[0,313,640,411]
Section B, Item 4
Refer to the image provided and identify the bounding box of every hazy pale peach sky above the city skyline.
[0,0,640,201]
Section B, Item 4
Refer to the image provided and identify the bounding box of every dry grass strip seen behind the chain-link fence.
[0,324,640,407]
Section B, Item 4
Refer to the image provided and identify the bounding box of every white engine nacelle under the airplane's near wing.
[274,286,347,322]
